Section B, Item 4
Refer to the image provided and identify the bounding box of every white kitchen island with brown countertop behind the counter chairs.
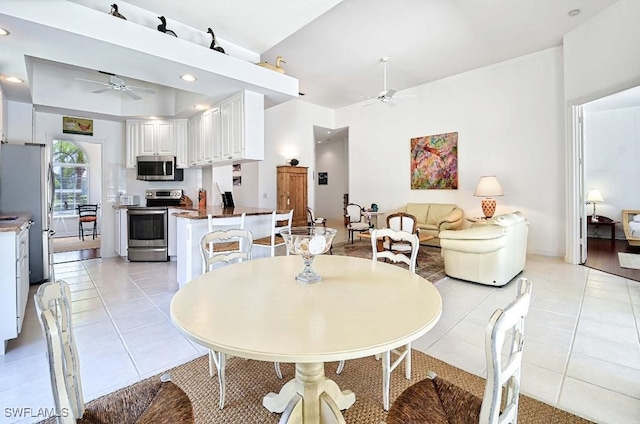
[170,206,273,287]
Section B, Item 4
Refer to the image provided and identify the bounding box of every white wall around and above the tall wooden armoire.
[262,100,336,210]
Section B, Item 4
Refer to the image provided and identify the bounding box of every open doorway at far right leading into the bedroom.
[574,87,640,281]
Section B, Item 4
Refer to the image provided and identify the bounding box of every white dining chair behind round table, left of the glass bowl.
[200,229,282,409]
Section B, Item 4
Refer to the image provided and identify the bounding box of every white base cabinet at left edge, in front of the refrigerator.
[0,221,31,355]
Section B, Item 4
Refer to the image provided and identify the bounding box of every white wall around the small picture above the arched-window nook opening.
[33,112,124,257]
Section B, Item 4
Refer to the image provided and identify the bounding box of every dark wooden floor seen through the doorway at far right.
[584,237,640,281]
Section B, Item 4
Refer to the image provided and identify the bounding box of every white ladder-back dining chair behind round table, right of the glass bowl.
[336,228,420,411]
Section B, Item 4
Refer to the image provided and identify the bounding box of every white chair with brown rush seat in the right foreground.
[386,278,532,424]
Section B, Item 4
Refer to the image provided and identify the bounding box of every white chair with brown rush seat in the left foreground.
[34,281,194,424]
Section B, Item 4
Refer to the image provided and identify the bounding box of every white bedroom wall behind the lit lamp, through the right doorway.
[584,107,640,239]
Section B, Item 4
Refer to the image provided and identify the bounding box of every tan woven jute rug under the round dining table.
[153,350,590,424]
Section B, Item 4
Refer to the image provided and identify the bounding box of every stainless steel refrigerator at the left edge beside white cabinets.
[0,144,53,284]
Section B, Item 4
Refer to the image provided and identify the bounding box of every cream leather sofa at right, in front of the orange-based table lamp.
[440,212,529,286]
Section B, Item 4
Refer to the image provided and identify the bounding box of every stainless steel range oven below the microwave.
[127,189,182,262]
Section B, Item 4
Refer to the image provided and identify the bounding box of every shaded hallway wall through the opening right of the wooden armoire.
[311,139,344,219]
